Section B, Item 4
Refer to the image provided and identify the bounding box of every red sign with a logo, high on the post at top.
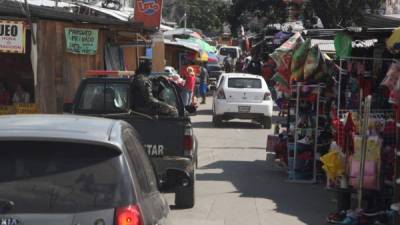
[134,0,163,29]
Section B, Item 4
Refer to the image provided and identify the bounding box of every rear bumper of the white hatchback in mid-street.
[214,99,273,119]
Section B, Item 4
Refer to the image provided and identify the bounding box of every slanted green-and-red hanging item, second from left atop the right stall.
[290,39,311,81]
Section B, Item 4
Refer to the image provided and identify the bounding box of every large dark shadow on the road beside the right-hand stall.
[197,160,333,225]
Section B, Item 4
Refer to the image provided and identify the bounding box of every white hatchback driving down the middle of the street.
[213,73,273,129]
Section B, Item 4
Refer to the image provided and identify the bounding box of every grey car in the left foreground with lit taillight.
[0,115,176,225]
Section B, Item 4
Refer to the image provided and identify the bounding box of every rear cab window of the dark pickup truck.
[79,82,129,113]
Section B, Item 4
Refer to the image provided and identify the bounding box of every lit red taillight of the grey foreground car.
[115,205,144,225]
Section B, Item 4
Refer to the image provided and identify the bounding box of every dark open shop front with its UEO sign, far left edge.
[0,20,37,114]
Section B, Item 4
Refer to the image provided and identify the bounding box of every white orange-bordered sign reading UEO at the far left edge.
[0,20,26,53]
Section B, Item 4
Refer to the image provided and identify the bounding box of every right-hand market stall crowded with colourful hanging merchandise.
[267,29,400,224]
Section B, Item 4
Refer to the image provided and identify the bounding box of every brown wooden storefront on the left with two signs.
[0,2,152,114]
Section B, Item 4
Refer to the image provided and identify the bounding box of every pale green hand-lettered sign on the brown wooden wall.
[65,28,99,55]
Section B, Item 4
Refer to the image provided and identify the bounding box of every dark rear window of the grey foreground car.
[0,141,132,213]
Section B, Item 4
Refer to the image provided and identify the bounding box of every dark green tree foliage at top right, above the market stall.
[228,0,384,31]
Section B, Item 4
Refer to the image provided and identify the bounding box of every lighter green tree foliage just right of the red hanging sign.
[163,0,229,34]
